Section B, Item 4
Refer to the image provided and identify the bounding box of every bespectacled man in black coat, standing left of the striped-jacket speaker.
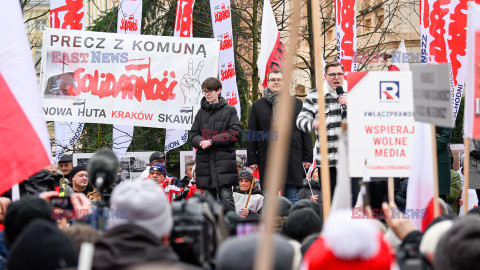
[247,70,313,204]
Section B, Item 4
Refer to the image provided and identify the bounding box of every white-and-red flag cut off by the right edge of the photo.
[463,3,480,139]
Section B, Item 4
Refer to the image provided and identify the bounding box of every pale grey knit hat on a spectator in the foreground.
[108,180,173,238]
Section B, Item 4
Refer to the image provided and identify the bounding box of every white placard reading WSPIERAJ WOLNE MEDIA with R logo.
[347,71,415,177]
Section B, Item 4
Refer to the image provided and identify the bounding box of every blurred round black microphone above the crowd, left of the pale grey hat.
[87,148,119,195]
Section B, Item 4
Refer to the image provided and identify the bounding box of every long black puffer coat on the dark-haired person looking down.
[190,97,240,189]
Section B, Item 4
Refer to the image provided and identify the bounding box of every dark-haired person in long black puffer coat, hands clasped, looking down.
[189,77,240,210]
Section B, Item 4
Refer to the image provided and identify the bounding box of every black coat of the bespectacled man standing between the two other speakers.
[247,98,313,187]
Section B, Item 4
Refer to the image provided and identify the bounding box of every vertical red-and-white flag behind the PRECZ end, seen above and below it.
[50,0,85,158]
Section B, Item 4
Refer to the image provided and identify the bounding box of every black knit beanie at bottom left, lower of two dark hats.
[7,219,78,270]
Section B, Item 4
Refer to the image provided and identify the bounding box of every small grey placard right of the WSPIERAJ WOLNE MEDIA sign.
[412,64,453,128]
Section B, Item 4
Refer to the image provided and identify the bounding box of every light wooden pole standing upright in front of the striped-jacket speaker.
[311,0,332,221]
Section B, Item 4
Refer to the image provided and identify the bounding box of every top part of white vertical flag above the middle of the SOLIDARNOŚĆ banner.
[117,0,142,35]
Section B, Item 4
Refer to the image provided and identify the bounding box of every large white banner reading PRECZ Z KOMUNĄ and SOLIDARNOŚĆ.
[40,29,220,130]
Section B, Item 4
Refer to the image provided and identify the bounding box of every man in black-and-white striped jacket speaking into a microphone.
[297,61,347,197]
